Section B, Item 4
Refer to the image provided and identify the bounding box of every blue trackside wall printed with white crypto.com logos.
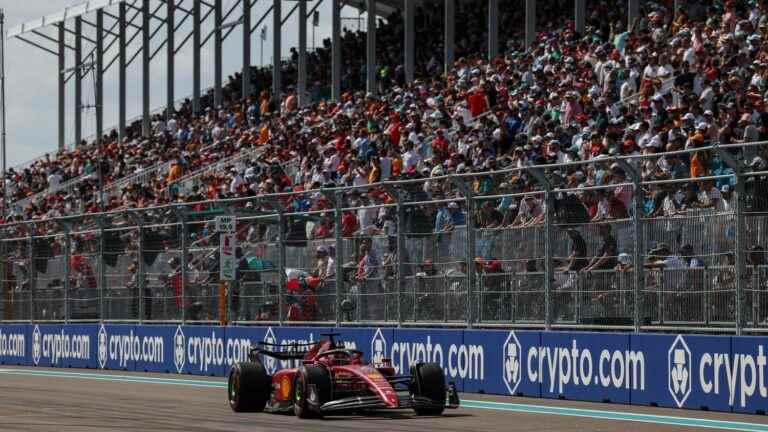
[0,324,768,413]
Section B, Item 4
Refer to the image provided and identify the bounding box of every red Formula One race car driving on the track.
[228,333,459,418]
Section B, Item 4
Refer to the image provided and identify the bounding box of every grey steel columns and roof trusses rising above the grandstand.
[7,0,648,149]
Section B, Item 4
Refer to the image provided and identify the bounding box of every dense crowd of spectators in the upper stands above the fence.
[4,0,768,276]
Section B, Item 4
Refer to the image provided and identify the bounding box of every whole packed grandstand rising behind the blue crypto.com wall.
[0,0,768,333]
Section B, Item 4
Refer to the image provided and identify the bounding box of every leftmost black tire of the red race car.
[227,362,272,412]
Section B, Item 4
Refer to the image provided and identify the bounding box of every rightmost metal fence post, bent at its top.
[714,145,746,335]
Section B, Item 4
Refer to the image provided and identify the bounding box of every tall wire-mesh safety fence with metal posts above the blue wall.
[0,143,768,333]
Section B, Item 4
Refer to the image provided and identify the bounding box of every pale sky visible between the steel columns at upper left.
[0,0,356,167]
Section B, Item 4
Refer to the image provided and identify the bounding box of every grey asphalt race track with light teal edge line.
[0,366,768,432]
